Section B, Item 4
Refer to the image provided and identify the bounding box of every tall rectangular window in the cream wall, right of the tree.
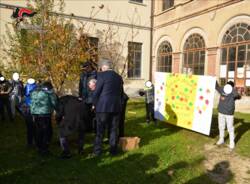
[128,42,142,78]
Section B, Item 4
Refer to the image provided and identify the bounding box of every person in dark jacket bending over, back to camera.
[56,95,90,158]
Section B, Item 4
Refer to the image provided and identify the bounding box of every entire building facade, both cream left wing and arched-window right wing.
[0,0,250,110]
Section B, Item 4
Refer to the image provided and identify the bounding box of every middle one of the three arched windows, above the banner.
[183,33,206,75]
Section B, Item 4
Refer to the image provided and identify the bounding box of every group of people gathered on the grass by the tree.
[0,59,128,158]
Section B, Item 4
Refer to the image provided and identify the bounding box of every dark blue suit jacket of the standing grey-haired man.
[93,70,123,113]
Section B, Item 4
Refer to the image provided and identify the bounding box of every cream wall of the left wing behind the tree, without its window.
[0,0,151,95]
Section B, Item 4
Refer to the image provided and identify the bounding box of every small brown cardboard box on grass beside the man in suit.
[119,137,141,151]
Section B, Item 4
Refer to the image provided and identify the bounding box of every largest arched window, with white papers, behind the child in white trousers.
[220,23,250,95]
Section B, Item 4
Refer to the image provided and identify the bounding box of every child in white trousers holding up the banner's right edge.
[216,81,240,149]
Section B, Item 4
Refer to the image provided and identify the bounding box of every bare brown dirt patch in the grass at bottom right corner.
[204,144,250,184]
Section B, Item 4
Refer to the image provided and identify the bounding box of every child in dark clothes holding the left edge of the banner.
[139,81,157,124]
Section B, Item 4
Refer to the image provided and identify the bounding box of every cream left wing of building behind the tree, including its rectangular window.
[0,0,152,96]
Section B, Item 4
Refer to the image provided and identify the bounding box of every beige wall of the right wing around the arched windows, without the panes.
[153,0,250,111]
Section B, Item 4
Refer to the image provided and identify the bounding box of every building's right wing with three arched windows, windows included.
[152,0,250,110]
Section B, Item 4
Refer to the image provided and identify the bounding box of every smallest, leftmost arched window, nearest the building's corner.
[157,41,172,72]
